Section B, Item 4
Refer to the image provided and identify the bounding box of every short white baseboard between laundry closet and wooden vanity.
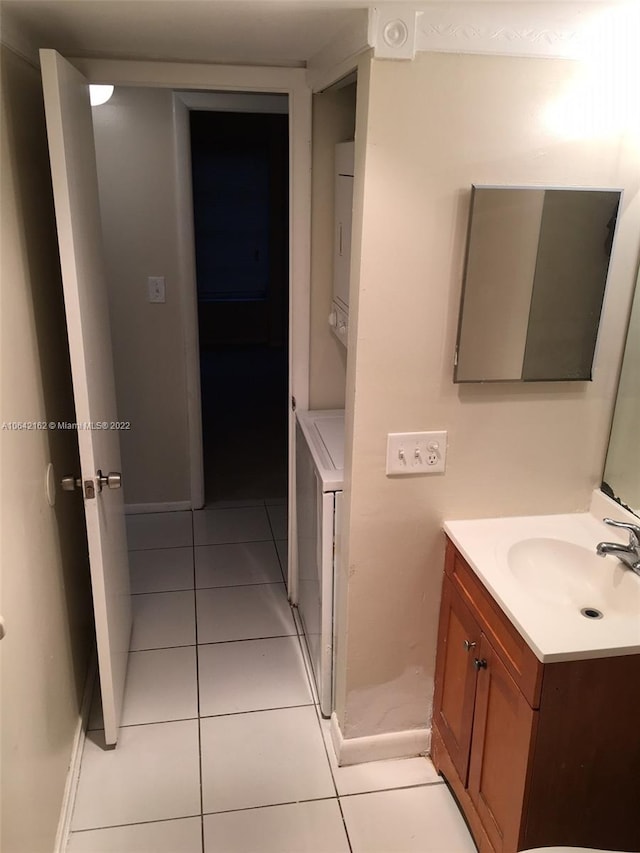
[331,711,431,767]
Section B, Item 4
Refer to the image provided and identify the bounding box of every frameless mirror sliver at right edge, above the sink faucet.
[602,266,640,515]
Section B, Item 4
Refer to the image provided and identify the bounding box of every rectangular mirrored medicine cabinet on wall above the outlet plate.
[454,191,621,382]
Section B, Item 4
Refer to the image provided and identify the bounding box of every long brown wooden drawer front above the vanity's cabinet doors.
[445,541,543,708]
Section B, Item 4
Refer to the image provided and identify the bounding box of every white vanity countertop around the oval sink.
[444,495,640,663]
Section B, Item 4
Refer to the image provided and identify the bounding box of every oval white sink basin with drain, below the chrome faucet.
[506,537,640,619]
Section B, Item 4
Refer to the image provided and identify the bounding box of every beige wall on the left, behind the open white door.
[0,47,92,853]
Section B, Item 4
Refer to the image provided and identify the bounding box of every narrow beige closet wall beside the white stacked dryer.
[309,85,356,409]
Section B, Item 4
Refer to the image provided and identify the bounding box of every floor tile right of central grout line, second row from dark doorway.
[195,541,282,589]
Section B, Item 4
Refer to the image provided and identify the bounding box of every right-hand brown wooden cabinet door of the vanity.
[469,635,538,853]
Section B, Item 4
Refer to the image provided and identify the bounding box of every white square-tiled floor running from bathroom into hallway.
[67,502,475,853]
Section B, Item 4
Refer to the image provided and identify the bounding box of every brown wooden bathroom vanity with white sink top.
[431,506,640,853]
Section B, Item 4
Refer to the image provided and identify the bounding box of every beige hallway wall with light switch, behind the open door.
[93,87,190,504]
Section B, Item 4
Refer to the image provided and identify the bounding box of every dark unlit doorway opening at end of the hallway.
[190,111,289,504]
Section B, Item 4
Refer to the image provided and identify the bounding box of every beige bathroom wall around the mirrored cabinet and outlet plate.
[337,53,640,737]
